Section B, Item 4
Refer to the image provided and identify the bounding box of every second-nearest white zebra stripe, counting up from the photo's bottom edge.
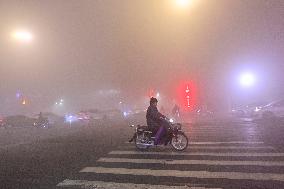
[80,167,284,182]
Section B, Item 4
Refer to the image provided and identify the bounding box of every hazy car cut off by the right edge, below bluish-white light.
[254,99,284,119]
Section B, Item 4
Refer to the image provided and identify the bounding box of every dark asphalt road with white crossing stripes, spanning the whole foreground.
[0,117,284,189]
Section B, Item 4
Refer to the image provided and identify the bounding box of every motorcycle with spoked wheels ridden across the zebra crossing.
[129,118,188,151]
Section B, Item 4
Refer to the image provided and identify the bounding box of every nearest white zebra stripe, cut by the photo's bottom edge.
[57,179,221,189]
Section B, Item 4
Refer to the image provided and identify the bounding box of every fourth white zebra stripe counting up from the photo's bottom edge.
[109,150,284,157]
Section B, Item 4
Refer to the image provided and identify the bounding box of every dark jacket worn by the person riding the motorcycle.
[146,106,165,128]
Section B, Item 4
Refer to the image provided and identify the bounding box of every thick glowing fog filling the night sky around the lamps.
[0,0,284,114]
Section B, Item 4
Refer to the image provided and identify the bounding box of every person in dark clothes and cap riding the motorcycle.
[146,97,168,145]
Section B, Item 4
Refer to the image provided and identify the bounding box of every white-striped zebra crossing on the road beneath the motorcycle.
[57,124,284,189]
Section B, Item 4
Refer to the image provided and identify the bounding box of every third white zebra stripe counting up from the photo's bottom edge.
[98,158,284,167]
